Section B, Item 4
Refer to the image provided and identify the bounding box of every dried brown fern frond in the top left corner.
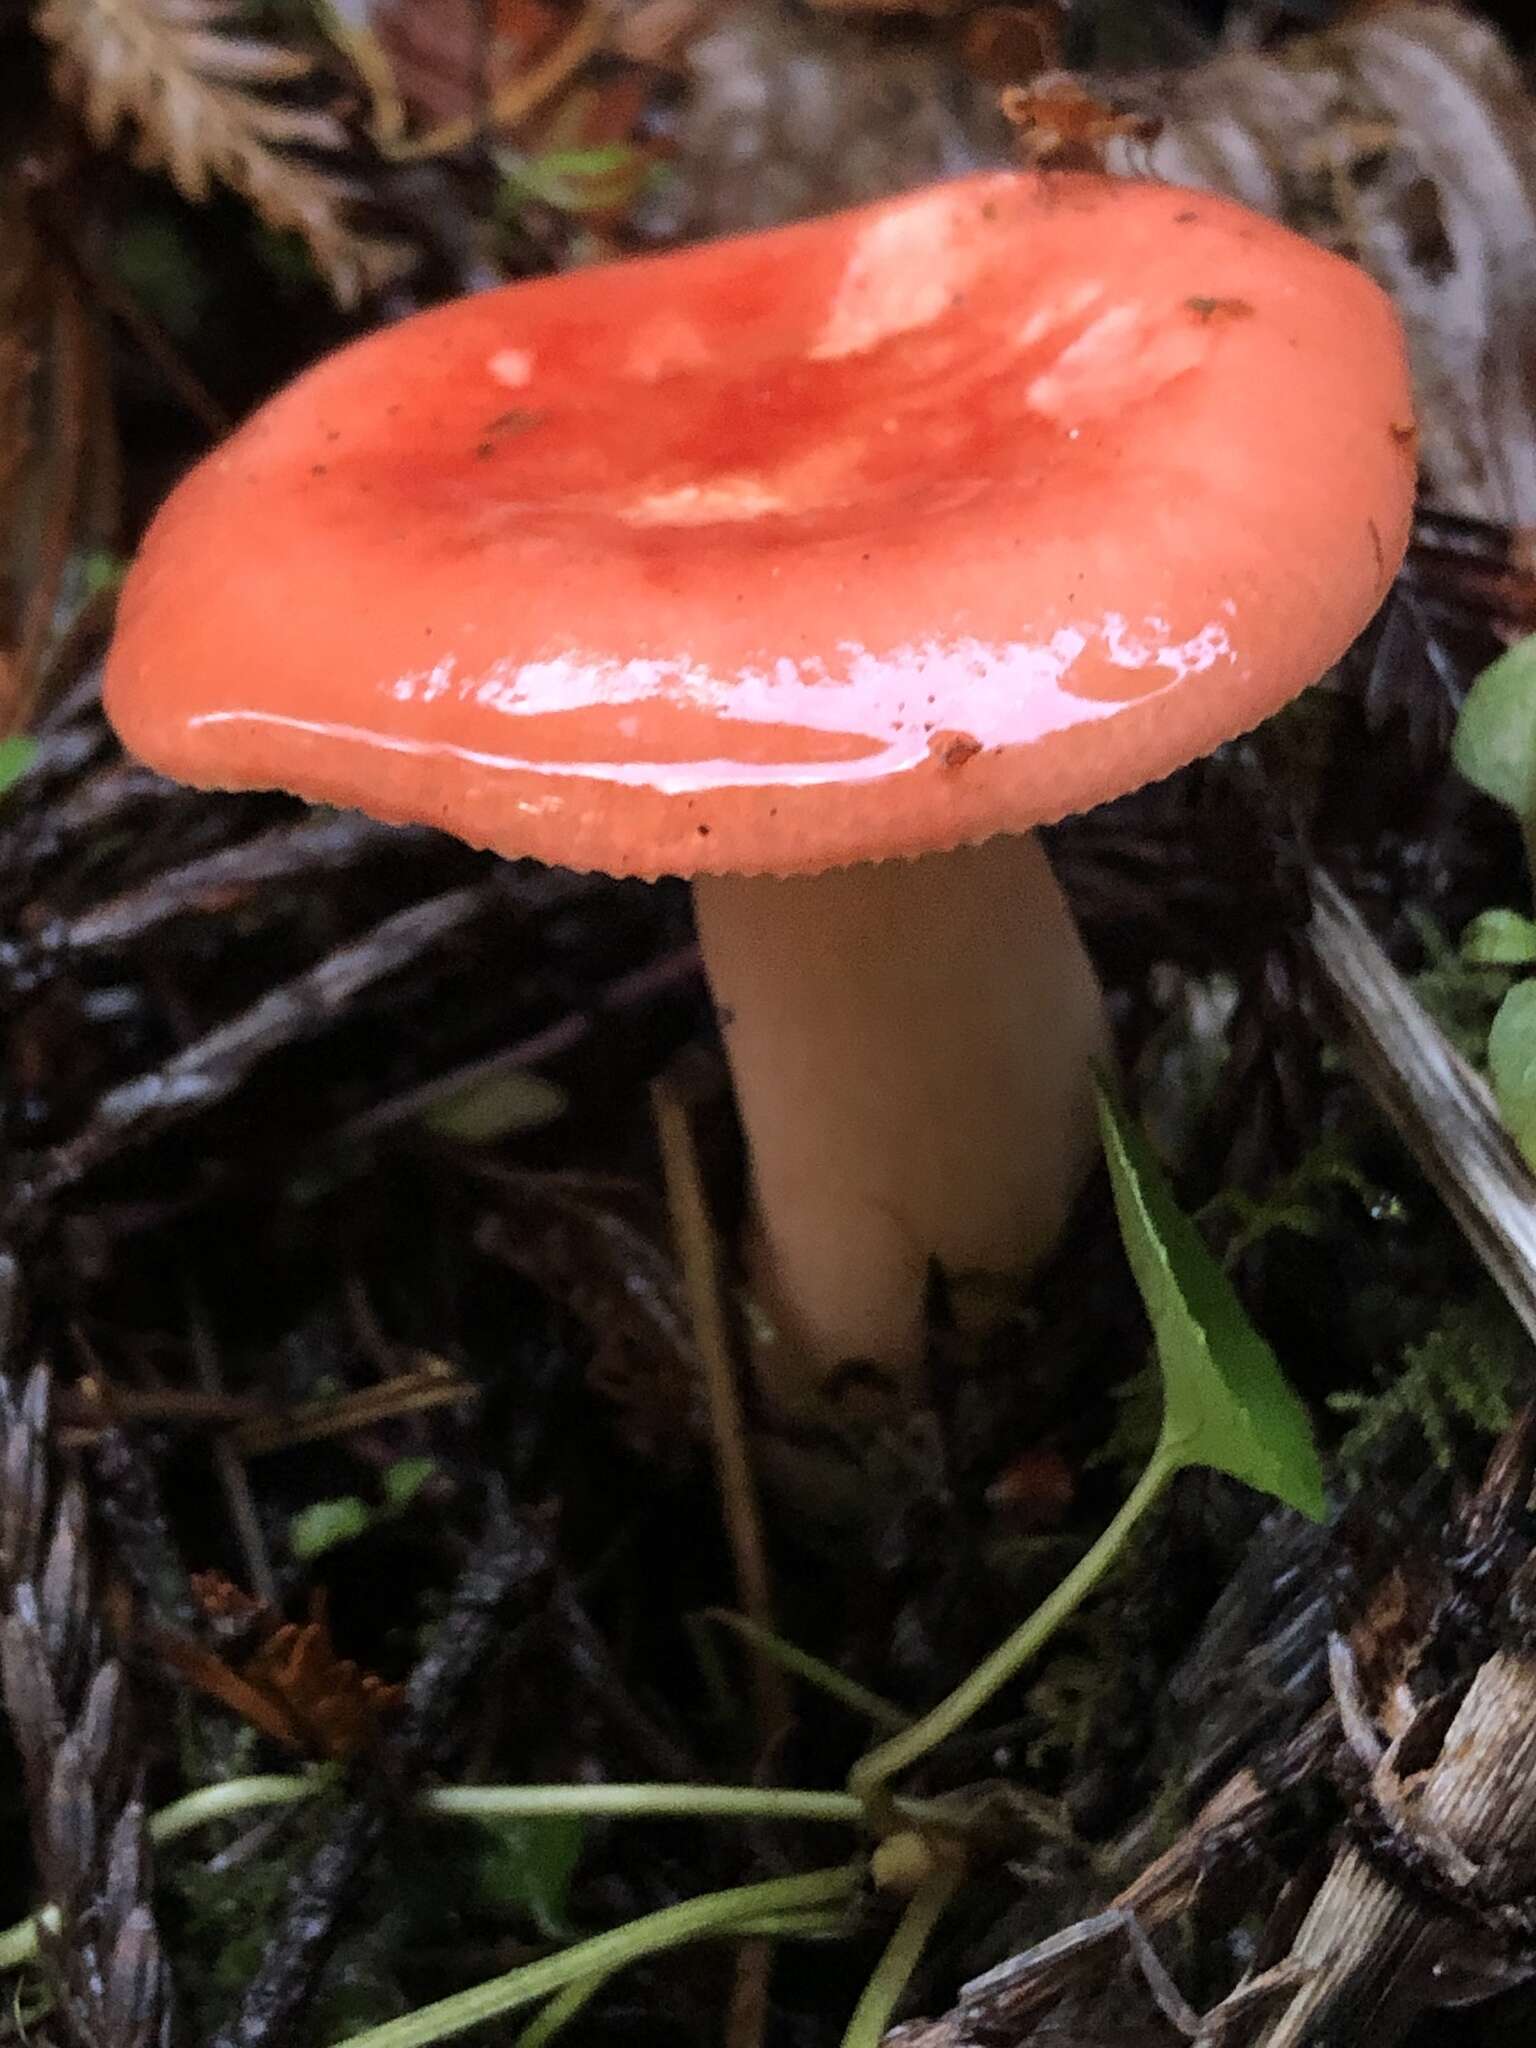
[35,0,403,305]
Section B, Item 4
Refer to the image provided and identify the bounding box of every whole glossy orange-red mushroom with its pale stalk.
[106,172,1413,1403]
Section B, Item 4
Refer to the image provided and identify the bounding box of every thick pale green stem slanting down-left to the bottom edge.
[338,1864,862,2048]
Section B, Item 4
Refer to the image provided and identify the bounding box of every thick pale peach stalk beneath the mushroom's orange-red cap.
[694,836,1108,1407]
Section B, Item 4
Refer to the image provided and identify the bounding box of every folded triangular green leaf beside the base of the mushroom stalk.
[1100,1090,1323,1520]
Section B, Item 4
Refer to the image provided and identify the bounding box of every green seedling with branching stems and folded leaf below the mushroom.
[69,1089,1327,2048]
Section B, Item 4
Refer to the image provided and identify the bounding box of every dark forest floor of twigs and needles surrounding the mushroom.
[0,0,1536,2048]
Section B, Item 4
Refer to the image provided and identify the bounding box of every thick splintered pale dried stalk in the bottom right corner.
[1245,1409,1536,2048]
